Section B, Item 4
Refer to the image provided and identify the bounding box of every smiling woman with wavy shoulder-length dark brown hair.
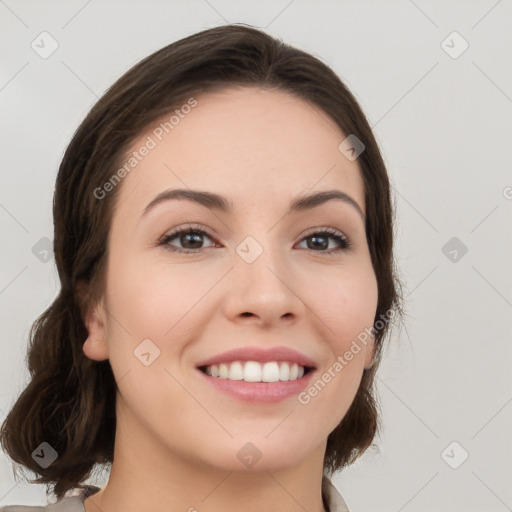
[0,25,401,512]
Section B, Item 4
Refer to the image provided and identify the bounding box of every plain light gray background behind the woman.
[0,0,512,512]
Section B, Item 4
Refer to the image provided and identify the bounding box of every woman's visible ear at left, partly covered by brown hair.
[78,284,109,361]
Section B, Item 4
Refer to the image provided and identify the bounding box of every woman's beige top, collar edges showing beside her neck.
[0,475,349,512]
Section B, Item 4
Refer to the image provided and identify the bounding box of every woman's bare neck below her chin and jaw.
[84,402,325,512]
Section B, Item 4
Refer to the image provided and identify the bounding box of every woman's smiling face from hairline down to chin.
[84,88,377,470]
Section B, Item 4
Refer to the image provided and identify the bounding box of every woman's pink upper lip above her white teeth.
[196,346,315,368]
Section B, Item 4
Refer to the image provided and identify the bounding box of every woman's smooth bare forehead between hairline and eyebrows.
[114,87,364,215]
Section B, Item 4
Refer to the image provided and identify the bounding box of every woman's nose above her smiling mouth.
[223,244,305,326]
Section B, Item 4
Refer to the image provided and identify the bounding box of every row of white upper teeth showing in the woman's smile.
[205,361,304,382]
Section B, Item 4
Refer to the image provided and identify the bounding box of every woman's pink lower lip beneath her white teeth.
[197,369,315,402]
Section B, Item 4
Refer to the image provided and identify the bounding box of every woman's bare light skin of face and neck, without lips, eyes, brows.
[83,87,377,512]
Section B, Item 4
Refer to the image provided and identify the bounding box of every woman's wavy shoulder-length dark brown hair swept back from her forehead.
[0,24,403,499]
